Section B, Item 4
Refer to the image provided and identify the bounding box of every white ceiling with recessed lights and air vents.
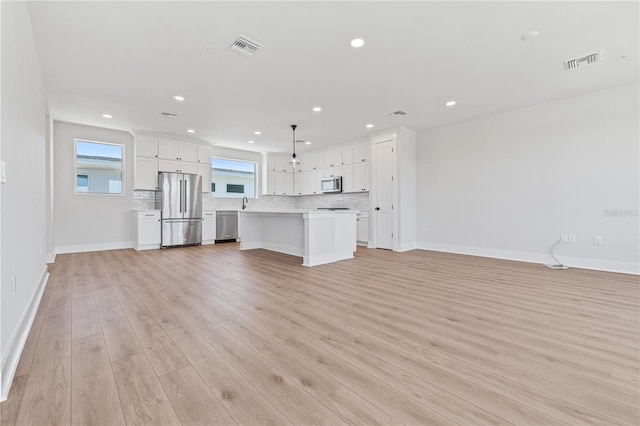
[29,1,640,152]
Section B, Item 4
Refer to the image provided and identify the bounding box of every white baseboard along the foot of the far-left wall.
[0,265,49,401]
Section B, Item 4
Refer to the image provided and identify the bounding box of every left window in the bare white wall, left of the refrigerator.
[75,139,124,194]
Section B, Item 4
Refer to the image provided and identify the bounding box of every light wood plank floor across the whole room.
[2,244,640,425]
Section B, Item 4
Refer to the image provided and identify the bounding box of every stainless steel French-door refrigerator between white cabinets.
[158,173,202,247]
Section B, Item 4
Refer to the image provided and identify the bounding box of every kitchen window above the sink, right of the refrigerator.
[211,157,256,198]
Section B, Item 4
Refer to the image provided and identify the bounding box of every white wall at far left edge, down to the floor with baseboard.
[0,2,47,399]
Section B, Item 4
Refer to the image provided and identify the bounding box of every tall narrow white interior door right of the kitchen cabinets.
[373,140,395,250]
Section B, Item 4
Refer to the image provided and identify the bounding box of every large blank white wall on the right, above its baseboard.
[416,84,640,273]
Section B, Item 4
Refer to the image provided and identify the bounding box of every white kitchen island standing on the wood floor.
[240,210,357,266]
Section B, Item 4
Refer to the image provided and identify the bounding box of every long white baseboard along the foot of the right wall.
[417,243,640,275]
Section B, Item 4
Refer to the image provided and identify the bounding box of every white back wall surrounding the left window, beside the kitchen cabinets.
[54,121,133,253]
